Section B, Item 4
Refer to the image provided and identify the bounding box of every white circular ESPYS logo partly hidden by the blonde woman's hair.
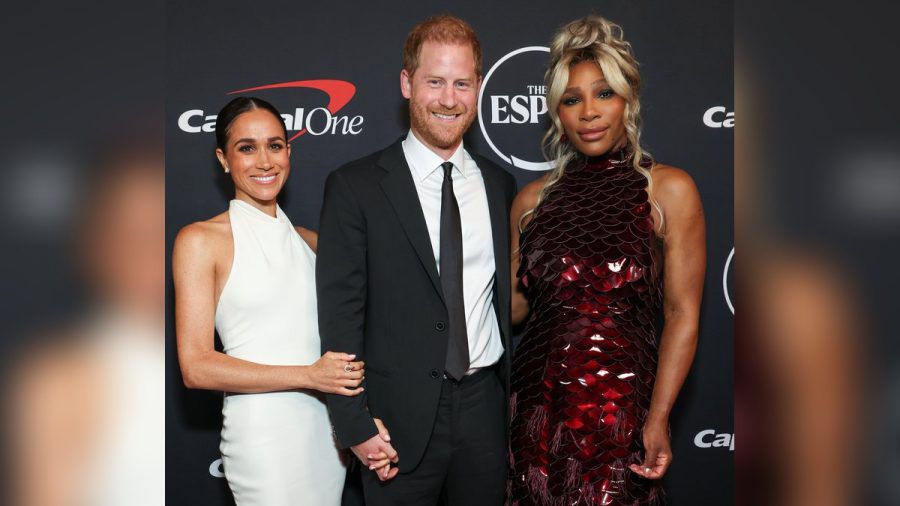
[478,46,551,171]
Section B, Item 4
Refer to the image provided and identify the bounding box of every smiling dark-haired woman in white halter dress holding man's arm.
[172,97,374,506]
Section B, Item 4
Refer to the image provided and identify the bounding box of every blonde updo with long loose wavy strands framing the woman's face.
[519,15,664,231]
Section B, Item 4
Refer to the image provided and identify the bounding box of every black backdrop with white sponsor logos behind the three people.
[166,0,734,506]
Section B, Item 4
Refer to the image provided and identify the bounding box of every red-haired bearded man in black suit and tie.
[316,16,516,506]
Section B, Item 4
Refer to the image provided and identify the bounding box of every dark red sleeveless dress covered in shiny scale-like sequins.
[509,151,662,506]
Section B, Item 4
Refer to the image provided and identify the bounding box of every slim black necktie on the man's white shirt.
[440,162,469,380]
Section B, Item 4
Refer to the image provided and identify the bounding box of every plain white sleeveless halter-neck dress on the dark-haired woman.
[216,200,346,506]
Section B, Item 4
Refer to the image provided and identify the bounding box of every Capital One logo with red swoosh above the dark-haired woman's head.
[178,79,363,142]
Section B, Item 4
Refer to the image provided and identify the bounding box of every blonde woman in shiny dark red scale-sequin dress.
[509,16,706,506]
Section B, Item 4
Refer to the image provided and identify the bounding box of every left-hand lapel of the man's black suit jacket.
[378,139,444,300]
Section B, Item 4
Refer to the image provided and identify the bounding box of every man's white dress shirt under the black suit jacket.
[403,130,503,374]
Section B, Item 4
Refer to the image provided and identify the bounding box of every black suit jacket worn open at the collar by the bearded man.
[316,139,516,471]
